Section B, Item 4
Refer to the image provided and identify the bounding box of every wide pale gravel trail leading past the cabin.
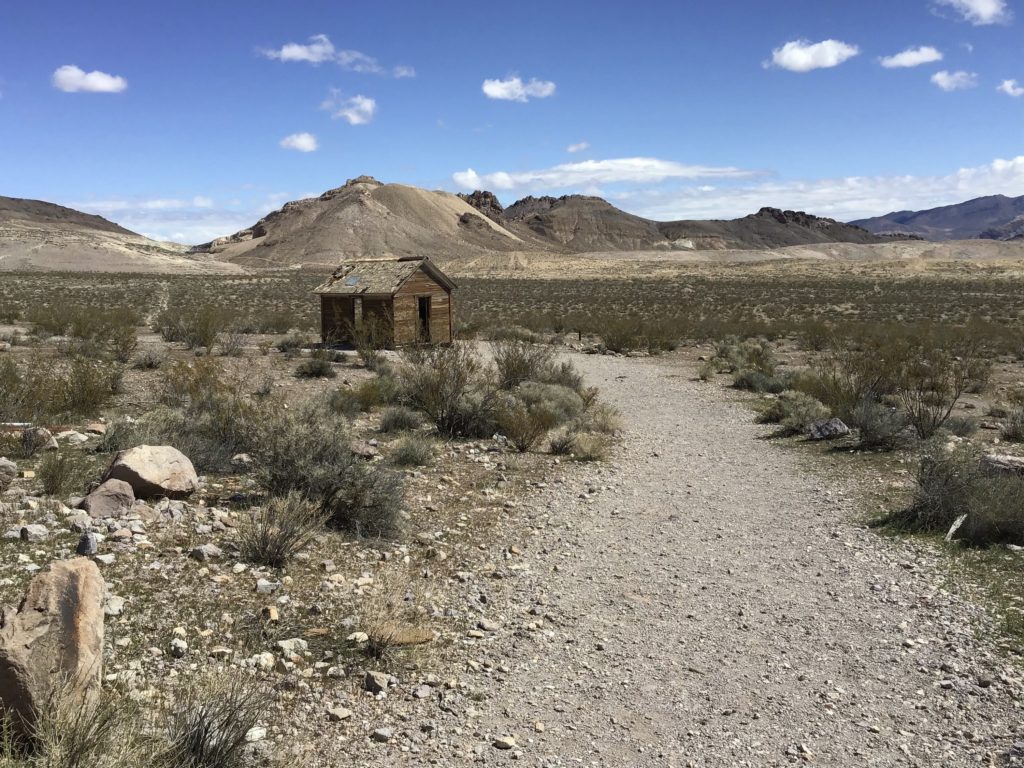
[473,356,1024,766]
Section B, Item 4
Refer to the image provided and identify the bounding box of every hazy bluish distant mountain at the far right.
[850,195,1024,241]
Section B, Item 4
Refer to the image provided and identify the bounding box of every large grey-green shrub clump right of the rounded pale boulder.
[250,402,402,536]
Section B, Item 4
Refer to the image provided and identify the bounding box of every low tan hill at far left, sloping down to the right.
[0,197,238,272]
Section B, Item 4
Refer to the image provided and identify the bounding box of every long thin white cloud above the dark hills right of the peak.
[452,158,757,190]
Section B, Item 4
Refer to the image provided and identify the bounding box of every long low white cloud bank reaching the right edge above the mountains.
[610,156,1024,221]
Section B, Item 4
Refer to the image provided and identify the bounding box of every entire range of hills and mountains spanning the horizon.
[0,176,1024,272]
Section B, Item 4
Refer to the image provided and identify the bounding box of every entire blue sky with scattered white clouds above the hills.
[0,0,1024,243]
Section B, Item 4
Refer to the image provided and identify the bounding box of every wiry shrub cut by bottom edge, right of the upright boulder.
[164,672,270,768]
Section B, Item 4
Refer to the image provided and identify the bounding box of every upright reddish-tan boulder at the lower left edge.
[0,557,103,737]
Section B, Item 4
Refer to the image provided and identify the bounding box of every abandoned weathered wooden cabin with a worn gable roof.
[313,256,456,346]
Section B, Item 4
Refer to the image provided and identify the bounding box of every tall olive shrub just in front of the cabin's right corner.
[398,344,496,436]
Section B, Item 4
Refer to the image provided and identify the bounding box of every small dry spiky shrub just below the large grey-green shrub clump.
[239,490,326,568]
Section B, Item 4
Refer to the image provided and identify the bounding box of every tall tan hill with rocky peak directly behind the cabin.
[193,176,546,267]
